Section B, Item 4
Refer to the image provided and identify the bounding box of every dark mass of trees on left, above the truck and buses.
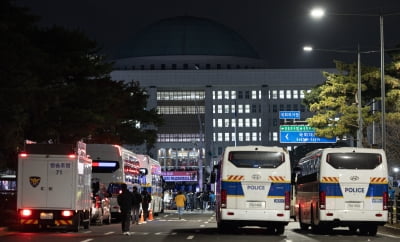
[0,0,162,168]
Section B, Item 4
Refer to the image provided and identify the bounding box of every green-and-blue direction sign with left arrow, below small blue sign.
[280,125,336,143]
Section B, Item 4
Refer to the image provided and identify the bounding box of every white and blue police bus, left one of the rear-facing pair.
[211,146,291,234]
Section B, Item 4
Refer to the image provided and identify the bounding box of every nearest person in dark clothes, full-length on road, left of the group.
[117,183,133,235]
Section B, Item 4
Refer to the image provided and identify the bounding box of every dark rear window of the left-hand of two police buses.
[228,151,285,168]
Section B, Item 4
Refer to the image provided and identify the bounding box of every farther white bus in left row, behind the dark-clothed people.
[137,155,163,215]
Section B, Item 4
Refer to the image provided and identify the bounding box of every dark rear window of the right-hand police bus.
[326,153,382,170]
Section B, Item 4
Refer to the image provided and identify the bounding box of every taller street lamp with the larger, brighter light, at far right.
[310,7,400,150]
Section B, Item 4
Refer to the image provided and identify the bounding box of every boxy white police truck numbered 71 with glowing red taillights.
[17,142,92,231]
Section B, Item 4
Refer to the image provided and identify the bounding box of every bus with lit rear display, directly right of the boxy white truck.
[86,144,141,219]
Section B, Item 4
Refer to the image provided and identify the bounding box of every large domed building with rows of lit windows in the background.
[111,17,334,190]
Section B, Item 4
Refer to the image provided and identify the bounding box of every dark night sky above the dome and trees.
[15,0,400,68]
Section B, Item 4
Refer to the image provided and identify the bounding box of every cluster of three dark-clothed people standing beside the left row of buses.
[117,183,151,235]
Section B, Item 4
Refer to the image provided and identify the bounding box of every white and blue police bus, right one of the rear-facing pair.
[296,147,388,236]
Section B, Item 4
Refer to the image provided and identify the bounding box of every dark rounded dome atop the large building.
[120,16,259,59]
